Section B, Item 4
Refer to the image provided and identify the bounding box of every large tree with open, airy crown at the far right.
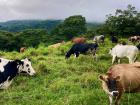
[99,5,140,36]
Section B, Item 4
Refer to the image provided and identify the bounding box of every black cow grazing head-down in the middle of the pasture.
[65,43,98,58]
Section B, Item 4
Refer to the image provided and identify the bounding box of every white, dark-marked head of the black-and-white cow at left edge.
[20,58,36,76]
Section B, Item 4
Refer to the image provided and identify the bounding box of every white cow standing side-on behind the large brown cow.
[109,44,138,64]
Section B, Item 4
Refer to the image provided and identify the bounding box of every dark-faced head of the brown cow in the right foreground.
[99,75,120,96]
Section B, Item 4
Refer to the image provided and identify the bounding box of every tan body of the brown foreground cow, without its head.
[107,64,140,92]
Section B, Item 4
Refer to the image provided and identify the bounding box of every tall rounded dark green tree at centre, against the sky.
[52,15,87,39]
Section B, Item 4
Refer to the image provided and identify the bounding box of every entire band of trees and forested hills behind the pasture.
[0,5,140,51]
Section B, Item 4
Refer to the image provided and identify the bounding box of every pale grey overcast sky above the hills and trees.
[0,0,140,22]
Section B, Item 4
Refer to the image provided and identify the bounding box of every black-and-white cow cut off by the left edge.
[0,58,35,89]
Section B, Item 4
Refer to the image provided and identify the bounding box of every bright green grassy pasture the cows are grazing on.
[0,39,140,105]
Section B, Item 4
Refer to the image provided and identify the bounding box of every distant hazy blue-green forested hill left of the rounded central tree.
[0,20,62,32]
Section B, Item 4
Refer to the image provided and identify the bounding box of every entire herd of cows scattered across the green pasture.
[0,35,140,105]
